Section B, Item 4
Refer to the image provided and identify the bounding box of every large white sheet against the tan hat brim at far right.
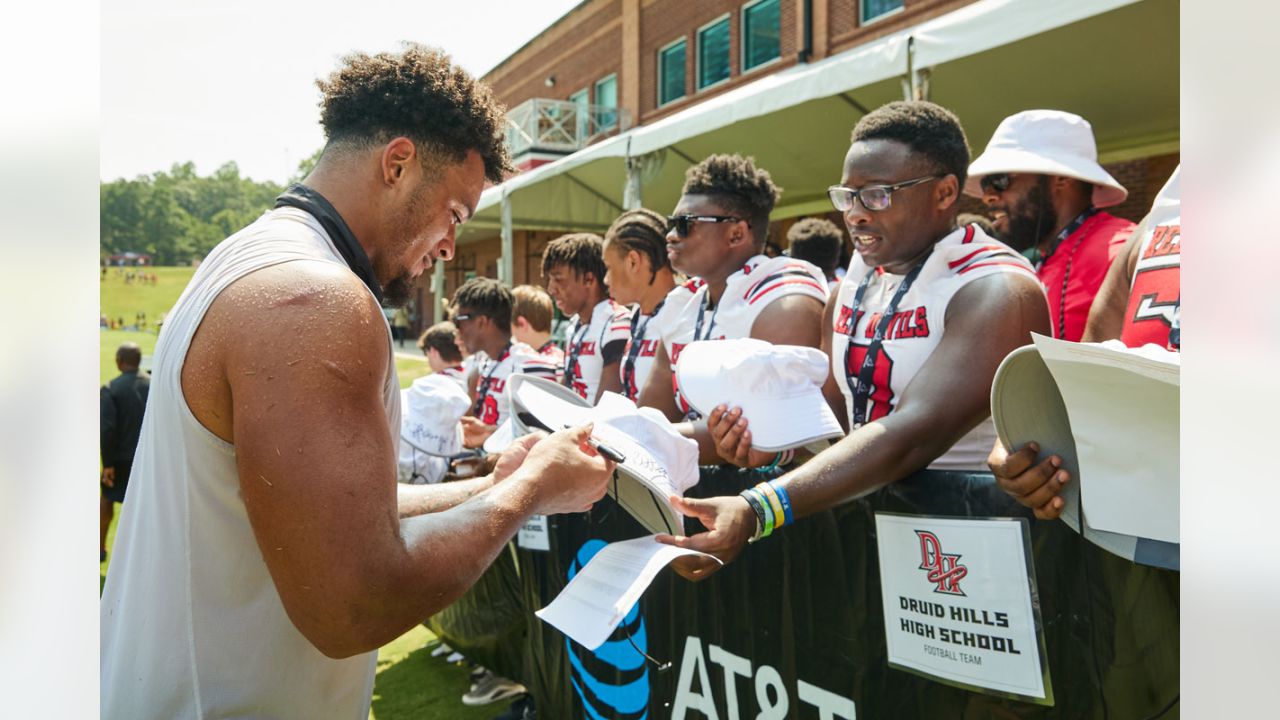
[1032,334,1180,543]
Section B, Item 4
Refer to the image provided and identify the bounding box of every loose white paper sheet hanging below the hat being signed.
[536,536,718,650]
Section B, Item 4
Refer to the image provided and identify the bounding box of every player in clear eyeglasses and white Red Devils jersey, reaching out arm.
[660,101,1050,571]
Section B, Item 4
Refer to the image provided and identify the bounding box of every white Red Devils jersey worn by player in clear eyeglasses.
[831,225,1039,471]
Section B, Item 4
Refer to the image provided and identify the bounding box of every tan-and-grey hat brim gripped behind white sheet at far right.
[991,345,1180,570]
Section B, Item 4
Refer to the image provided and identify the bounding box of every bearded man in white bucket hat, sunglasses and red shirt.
[964,110,1133,342]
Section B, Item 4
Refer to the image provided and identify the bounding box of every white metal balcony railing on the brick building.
[507,97,631,158]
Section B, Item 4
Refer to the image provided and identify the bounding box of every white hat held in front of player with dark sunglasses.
[676,338,845,452]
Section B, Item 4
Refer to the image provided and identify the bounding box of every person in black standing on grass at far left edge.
[99,342,151,561]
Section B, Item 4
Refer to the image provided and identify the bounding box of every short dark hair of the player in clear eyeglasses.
[852,100,969,187]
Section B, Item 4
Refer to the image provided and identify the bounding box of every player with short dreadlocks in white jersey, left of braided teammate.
[543,233,631,405]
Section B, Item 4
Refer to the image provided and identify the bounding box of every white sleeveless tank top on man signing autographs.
[100,208,399,720]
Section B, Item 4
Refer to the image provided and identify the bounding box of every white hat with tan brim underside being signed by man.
[508,375,698,534]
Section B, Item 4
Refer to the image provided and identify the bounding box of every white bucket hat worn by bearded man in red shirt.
[964,110,1129,208]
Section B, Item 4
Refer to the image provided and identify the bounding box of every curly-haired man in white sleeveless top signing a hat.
[101,46,611,720]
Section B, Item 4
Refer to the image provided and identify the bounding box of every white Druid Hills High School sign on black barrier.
[876,512,1053,705]
